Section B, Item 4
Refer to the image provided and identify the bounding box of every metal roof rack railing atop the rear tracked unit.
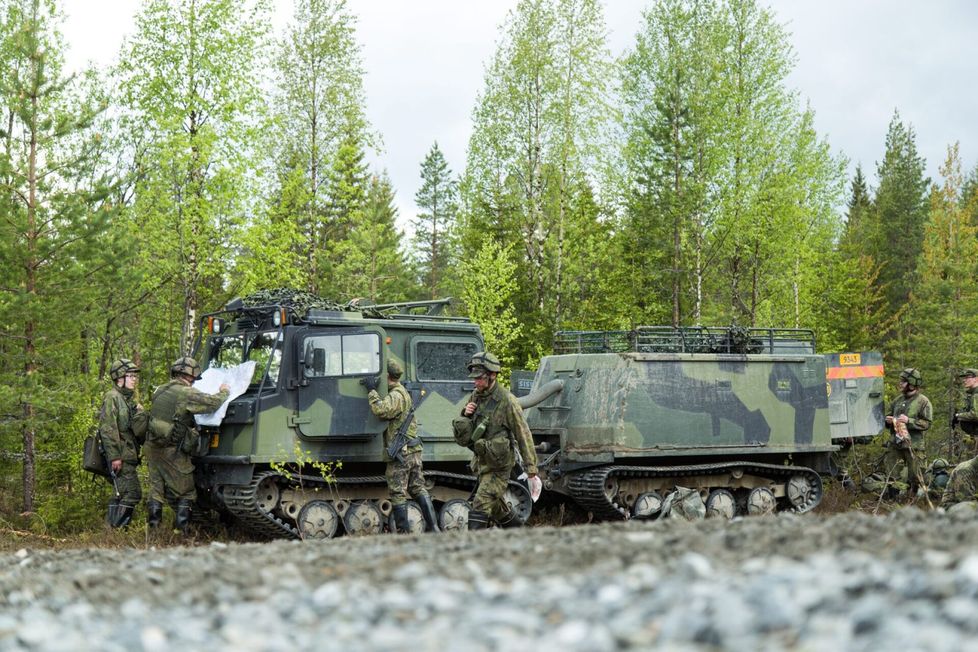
[554,326,815,354]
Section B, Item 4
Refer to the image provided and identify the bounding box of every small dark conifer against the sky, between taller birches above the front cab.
[412,142,458,299]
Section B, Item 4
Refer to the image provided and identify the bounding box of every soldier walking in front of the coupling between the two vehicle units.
[452,351,542,530]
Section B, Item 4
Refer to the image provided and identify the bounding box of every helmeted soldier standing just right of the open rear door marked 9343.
[884,369,933,500]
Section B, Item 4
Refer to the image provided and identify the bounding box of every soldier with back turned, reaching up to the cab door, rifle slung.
[364,360,441,532]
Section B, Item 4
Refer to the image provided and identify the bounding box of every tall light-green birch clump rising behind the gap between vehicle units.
[460,0,612,357]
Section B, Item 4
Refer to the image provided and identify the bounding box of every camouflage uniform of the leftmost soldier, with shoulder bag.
[98,385,143,527]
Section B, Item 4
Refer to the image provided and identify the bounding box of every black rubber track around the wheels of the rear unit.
[568,462,822,520]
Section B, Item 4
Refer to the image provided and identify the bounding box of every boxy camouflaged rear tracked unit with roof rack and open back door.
[526,327,883,519]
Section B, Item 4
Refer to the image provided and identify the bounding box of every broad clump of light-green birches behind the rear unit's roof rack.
[621,0,844,325]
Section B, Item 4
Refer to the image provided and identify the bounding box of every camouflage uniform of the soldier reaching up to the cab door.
[367,383,428,505]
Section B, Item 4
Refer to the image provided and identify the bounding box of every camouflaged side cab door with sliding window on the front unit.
[294,326,387,441]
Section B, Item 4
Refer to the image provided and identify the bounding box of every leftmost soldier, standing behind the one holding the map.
[98,358,146,527]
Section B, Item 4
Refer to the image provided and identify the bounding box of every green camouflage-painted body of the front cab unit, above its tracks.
[200,300,484,472]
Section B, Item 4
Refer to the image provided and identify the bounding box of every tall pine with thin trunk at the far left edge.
[0,0,114,514]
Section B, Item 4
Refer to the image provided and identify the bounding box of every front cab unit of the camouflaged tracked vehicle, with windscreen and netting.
[187,290,532,538]
